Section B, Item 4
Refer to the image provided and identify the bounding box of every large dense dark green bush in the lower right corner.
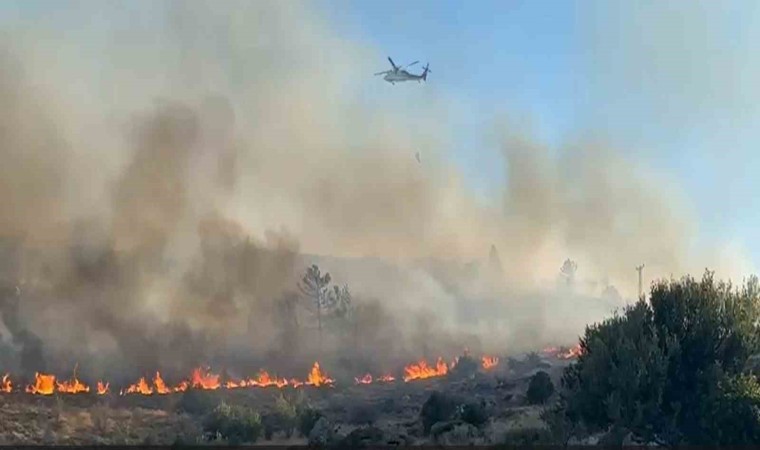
[561,272,760,444]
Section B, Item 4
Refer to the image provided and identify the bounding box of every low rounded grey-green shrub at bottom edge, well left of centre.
[203,402,262,445]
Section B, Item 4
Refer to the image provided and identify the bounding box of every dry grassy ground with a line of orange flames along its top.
[0,346,566,445]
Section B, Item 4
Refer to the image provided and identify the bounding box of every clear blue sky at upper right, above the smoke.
[320,0,760,267]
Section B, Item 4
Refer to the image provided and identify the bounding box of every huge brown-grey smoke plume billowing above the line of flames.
[0,2,752,377]
